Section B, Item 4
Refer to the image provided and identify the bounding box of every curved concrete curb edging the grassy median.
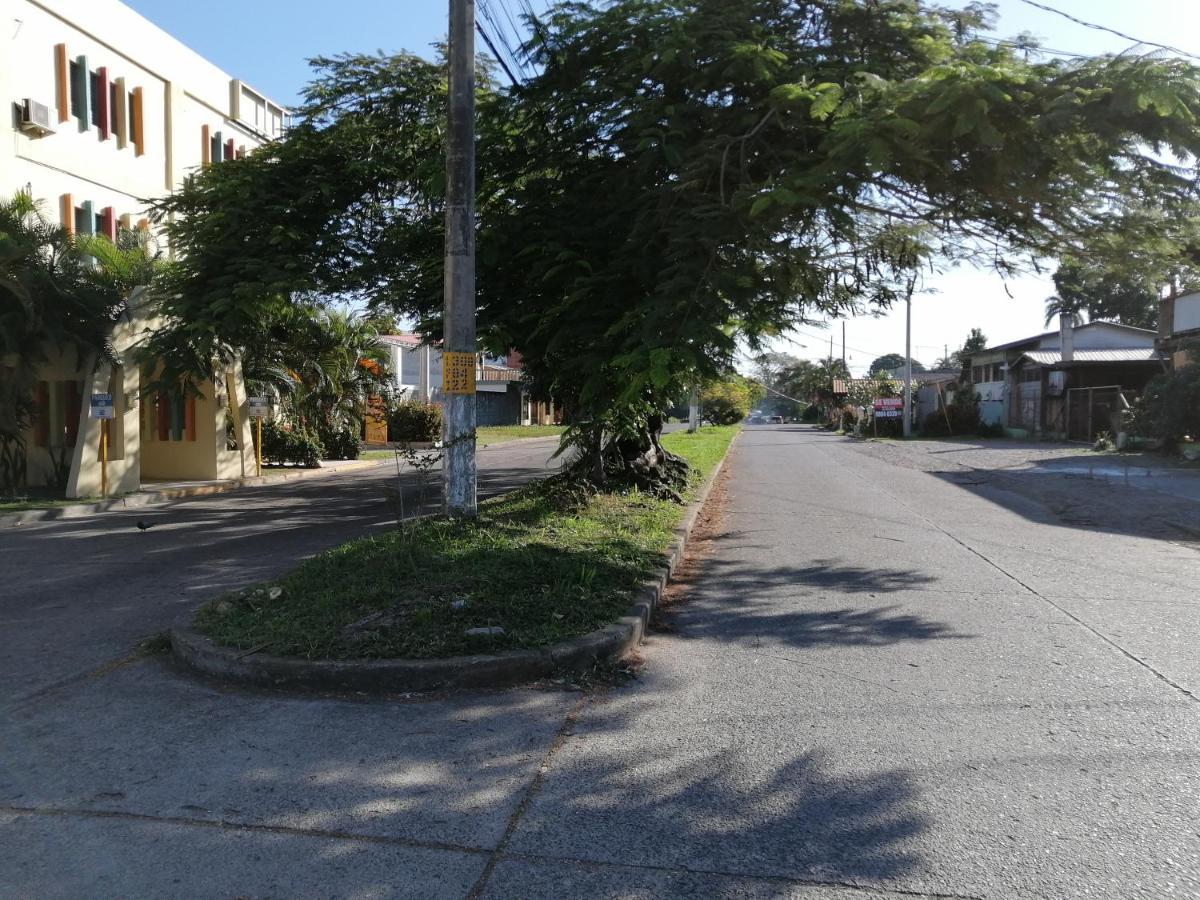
[170,432,742,694]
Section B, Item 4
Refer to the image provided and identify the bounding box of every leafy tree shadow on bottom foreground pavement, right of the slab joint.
[512,734,930,886]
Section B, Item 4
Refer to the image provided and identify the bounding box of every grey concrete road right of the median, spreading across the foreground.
[0,427,1200,900]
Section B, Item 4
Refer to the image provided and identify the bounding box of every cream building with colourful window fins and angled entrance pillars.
[0,0,287,497]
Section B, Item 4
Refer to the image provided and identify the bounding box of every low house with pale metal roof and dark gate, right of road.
[971,322,1168,442]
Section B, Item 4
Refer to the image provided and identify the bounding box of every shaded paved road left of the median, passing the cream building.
[0,438,558,697]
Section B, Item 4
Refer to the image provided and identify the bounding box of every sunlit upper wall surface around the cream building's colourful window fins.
[0,0,283,224]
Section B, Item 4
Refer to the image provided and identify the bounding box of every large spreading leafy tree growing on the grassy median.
[145,0,1200,494]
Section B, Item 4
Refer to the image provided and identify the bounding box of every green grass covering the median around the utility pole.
[197,427,738,659]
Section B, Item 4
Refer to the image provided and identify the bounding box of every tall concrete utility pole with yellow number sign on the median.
[442,0,478,518]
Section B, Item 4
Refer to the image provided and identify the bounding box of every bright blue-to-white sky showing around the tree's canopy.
[125,0,1200,373]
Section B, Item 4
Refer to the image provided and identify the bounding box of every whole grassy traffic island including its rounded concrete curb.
[172,428,737,692]
